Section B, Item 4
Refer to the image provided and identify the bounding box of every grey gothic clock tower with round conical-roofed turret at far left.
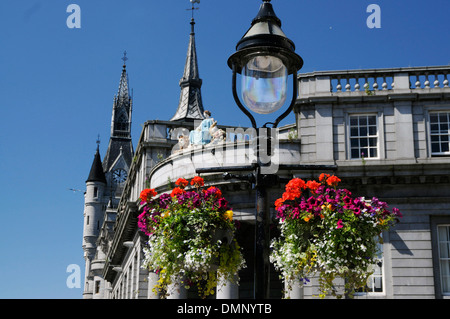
[83,52,134,299]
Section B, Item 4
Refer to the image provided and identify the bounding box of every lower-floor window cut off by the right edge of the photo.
[437,225,450,295]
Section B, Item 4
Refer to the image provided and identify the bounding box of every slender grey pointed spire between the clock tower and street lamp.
[171,8,203,121]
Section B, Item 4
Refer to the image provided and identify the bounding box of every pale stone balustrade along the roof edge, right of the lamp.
[298,66,450,98]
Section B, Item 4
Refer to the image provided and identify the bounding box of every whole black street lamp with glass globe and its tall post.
[228,0,303,299]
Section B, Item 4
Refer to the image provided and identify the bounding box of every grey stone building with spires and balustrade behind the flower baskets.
[83,15,450,299]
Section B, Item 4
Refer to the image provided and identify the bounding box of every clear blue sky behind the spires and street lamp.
[0,0,450,298]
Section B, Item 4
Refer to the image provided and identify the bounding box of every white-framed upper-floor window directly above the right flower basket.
[349,115,378,159]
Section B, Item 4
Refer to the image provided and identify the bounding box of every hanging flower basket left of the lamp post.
[138,176,245,298]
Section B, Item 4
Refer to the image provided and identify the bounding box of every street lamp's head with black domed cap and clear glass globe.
[228,0,303,119]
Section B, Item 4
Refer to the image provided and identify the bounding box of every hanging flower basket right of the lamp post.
[270,174,401,298]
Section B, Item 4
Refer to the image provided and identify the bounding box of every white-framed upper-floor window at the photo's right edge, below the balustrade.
[430,112,450,155]
